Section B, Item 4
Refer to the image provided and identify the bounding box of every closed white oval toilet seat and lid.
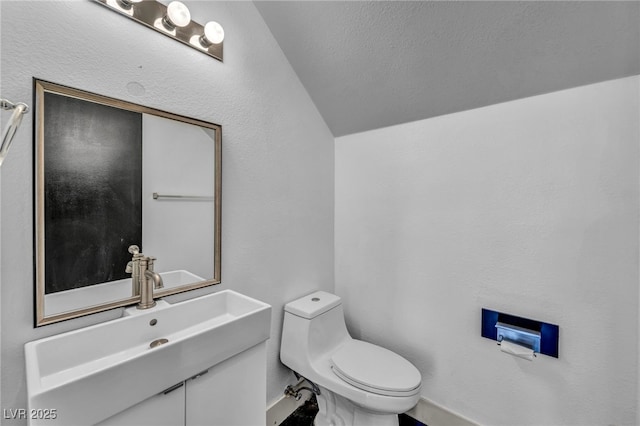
[331,340,421,396]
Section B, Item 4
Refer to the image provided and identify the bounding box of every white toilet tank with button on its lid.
[280,291,350,375]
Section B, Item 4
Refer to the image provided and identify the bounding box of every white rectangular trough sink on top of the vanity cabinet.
[25,290,271,425]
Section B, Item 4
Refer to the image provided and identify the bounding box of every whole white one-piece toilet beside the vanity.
[280,291,422,426]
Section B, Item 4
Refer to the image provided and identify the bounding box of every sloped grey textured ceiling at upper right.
[254,1,640,136]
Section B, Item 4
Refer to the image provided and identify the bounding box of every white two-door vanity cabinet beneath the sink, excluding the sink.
[97,342,267,426]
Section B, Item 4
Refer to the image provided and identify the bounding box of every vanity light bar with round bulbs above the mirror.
[94,0,224,62]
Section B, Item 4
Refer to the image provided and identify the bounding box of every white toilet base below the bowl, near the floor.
[313,387,398,426]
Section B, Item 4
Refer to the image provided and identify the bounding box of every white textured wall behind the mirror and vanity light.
[0,0,334,424]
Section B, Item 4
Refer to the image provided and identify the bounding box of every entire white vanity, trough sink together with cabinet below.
[25,290,271,426]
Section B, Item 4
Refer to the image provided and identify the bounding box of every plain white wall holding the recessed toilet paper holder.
[335,76,640,425]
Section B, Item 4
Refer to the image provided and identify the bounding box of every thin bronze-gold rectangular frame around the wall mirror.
[33,78,222,327]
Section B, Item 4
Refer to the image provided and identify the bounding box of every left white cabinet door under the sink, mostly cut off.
[97,383,185,426]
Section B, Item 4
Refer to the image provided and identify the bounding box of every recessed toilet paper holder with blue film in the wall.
[481,308,560,358]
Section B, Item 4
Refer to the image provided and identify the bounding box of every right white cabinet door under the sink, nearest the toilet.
[186,342,267,426]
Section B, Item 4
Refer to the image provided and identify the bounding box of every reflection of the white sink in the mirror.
[44,269,204,315]
